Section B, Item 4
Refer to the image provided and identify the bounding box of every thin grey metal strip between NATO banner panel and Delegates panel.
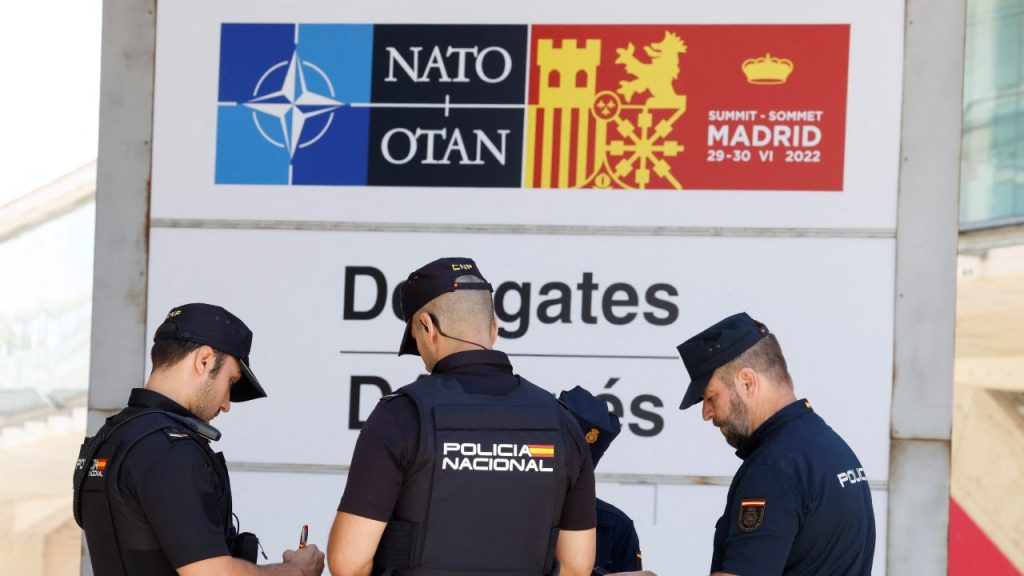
[150,218,896,239]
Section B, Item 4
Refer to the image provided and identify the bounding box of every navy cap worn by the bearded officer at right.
[676,312,768,410]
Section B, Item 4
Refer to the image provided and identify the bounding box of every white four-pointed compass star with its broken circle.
[244,51,342,158]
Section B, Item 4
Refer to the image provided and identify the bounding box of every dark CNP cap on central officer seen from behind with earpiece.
[398,258,494,356]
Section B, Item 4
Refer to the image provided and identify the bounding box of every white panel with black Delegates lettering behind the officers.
[148,225,893,567]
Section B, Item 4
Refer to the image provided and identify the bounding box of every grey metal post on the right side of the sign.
[887,0,967,574]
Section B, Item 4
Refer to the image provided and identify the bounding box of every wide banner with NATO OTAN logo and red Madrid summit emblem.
[215,24,849,191]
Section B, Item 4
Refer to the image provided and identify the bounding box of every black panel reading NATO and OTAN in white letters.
[368,26,527,188]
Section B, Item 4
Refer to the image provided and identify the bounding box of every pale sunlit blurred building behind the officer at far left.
[0,194,94,576]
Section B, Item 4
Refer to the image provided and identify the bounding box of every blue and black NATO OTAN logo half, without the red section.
[214,24,524,188]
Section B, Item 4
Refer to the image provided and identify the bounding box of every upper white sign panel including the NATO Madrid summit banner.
[152,1,902,229]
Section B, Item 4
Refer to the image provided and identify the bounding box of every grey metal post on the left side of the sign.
[82,0,157,575]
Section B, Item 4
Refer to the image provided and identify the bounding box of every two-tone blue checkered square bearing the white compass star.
[215,24,373,186]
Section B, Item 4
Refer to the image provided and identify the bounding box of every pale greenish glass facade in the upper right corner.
[961,0,1024,230]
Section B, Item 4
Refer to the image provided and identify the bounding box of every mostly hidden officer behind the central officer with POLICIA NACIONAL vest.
[558,386,642,576]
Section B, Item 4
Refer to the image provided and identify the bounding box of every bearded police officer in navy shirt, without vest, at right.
[678,313,874,576]
